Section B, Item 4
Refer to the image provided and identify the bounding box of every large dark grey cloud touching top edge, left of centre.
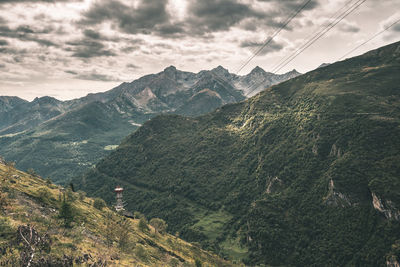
[80,0,170,34]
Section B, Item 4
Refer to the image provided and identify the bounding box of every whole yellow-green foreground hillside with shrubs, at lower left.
[0,159,232,266]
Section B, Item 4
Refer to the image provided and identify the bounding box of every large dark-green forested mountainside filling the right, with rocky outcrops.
[73,42,400,266]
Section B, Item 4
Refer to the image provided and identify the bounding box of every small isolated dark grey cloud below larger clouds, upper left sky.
[65,39,116,58]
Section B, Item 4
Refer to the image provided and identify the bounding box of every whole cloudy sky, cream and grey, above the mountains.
[0,0,400,101]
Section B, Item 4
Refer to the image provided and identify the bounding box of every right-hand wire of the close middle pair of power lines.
[272,0,366,74]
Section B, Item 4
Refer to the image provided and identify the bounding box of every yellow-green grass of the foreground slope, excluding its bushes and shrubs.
[0,163,230,266]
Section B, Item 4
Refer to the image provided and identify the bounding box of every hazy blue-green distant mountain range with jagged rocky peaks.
[0,66,298,183]
